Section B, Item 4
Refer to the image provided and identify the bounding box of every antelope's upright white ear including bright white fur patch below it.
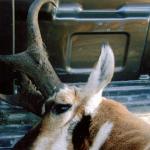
[84,44,115,113]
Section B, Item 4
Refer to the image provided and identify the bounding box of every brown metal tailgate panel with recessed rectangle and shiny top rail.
[49,4,150,82]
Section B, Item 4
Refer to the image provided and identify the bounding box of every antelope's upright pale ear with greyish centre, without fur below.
[85,44,115,95]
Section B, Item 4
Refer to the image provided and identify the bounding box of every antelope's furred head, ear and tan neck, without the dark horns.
[14,45,150,150]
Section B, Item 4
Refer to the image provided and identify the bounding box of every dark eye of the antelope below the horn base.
[51,104,72,115]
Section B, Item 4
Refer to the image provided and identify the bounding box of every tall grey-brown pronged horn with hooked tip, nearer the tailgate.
[0,0,62,98]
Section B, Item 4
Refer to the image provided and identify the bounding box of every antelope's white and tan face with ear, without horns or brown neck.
[10,44,114,150]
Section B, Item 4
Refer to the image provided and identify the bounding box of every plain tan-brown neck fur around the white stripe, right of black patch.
[90,99,150,150]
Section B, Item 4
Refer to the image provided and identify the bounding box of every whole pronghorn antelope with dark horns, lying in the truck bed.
[0,0,150,150]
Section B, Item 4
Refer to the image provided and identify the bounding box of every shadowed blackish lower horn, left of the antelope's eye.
[0,73,45,116]
